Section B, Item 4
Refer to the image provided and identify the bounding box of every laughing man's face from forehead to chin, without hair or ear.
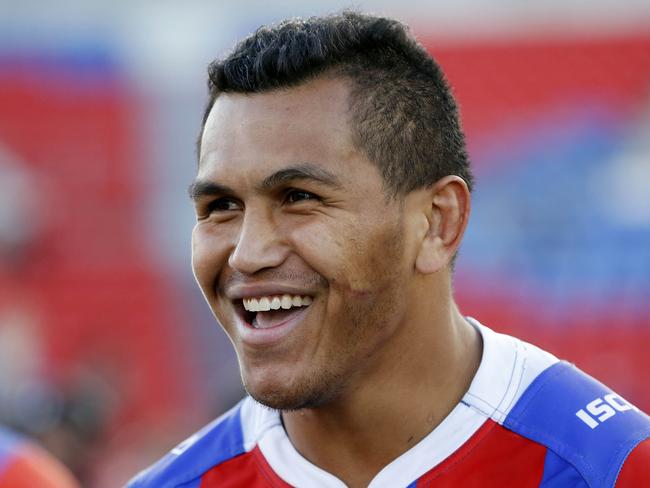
[191,79,413,410]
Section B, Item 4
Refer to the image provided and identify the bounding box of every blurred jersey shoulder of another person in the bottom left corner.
[0,428,79,488]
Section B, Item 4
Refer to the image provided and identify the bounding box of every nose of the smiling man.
[228,210,288,274]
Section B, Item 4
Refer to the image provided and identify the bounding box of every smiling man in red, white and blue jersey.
[131,13,650,488]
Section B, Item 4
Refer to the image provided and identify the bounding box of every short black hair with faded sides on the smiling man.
[199,11,473,196]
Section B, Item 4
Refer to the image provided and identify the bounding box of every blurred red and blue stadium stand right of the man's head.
[446,35,650,410]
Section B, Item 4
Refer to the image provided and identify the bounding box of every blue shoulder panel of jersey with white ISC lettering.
[503,362,650,487]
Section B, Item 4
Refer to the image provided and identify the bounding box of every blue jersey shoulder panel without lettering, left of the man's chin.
[128,402,244,488]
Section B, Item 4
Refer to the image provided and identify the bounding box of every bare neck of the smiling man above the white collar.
[282,304,482,488]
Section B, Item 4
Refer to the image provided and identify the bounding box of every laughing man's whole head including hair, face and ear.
[190,10,471,409]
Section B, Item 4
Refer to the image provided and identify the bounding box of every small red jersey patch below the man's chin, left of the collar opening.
[201,447,291,488]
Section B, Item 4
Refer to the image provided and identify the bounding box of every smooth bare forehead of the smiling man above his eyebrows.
[199,79,356,179]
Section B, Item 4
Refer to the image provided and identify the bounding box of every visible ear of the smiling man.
[415,175,470,274]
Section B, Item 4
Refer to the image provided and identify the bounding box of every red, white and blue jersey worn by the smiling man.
[129,319,650,488]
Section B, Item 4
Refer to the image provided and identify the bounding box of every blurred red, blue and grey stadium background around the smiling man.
[0,0,650,488]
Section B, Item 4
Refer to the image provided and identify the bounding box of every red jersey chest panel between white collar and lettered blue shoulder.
[417,420,546,488]
